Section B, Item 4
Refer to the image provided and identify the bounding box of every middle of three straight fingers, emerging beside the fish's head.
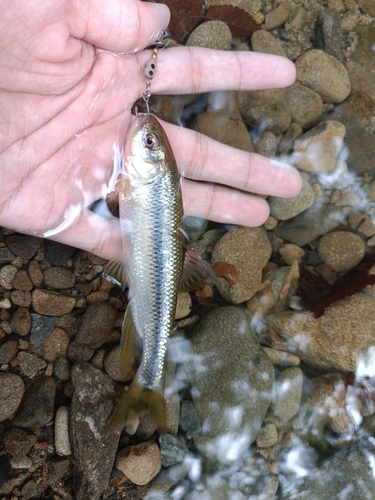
[163,122,302,198]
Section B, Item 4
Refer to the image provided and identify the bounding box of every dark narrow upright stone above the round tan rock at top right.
[315,9,341,61]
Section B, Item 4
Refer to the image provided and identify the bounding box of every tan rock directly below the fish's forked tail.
[116,441,161,485]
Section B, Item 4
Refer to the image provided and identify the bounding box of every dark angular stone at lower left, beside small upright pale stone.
[12,377,56,428]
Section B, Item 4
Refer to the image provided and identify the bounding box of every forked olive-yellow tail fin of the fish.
[107,379,167,433]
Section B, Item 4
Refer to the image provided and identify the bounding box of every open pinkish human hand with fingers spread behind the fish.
[0,0,301,258]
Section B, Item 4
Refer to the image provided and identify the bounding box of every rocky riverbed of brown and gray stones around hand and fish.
[0,0,375,500]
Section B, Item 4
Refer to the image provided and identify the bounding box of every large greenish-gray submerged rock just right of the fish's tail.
[191,307,274,462]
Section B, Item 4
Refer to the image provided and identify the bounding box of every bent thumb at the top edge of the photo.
[70,0,170,52]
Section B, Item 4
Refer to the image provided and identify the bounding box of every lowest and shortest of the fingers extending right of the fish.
[182,179,269,227]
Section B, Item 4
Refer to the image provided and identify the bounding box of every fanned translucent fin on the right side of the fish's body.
[180,250,216,292]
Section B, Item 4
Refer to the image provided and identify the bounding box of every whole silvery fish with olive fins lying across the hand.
[103,114,214,432]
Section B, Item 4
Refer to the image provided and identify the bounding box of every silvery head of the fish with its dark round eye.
[124,114,170,185]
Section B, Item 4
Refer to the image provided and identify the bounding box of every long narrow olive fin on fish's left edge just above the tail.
[120,301,142,376]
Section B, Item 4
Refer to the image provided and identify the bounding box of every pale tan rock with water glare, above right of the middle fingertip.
[294,120,345,172]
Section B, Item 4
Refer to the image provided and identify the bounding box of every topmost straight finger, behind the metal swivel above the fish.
[138,47,296,94]
